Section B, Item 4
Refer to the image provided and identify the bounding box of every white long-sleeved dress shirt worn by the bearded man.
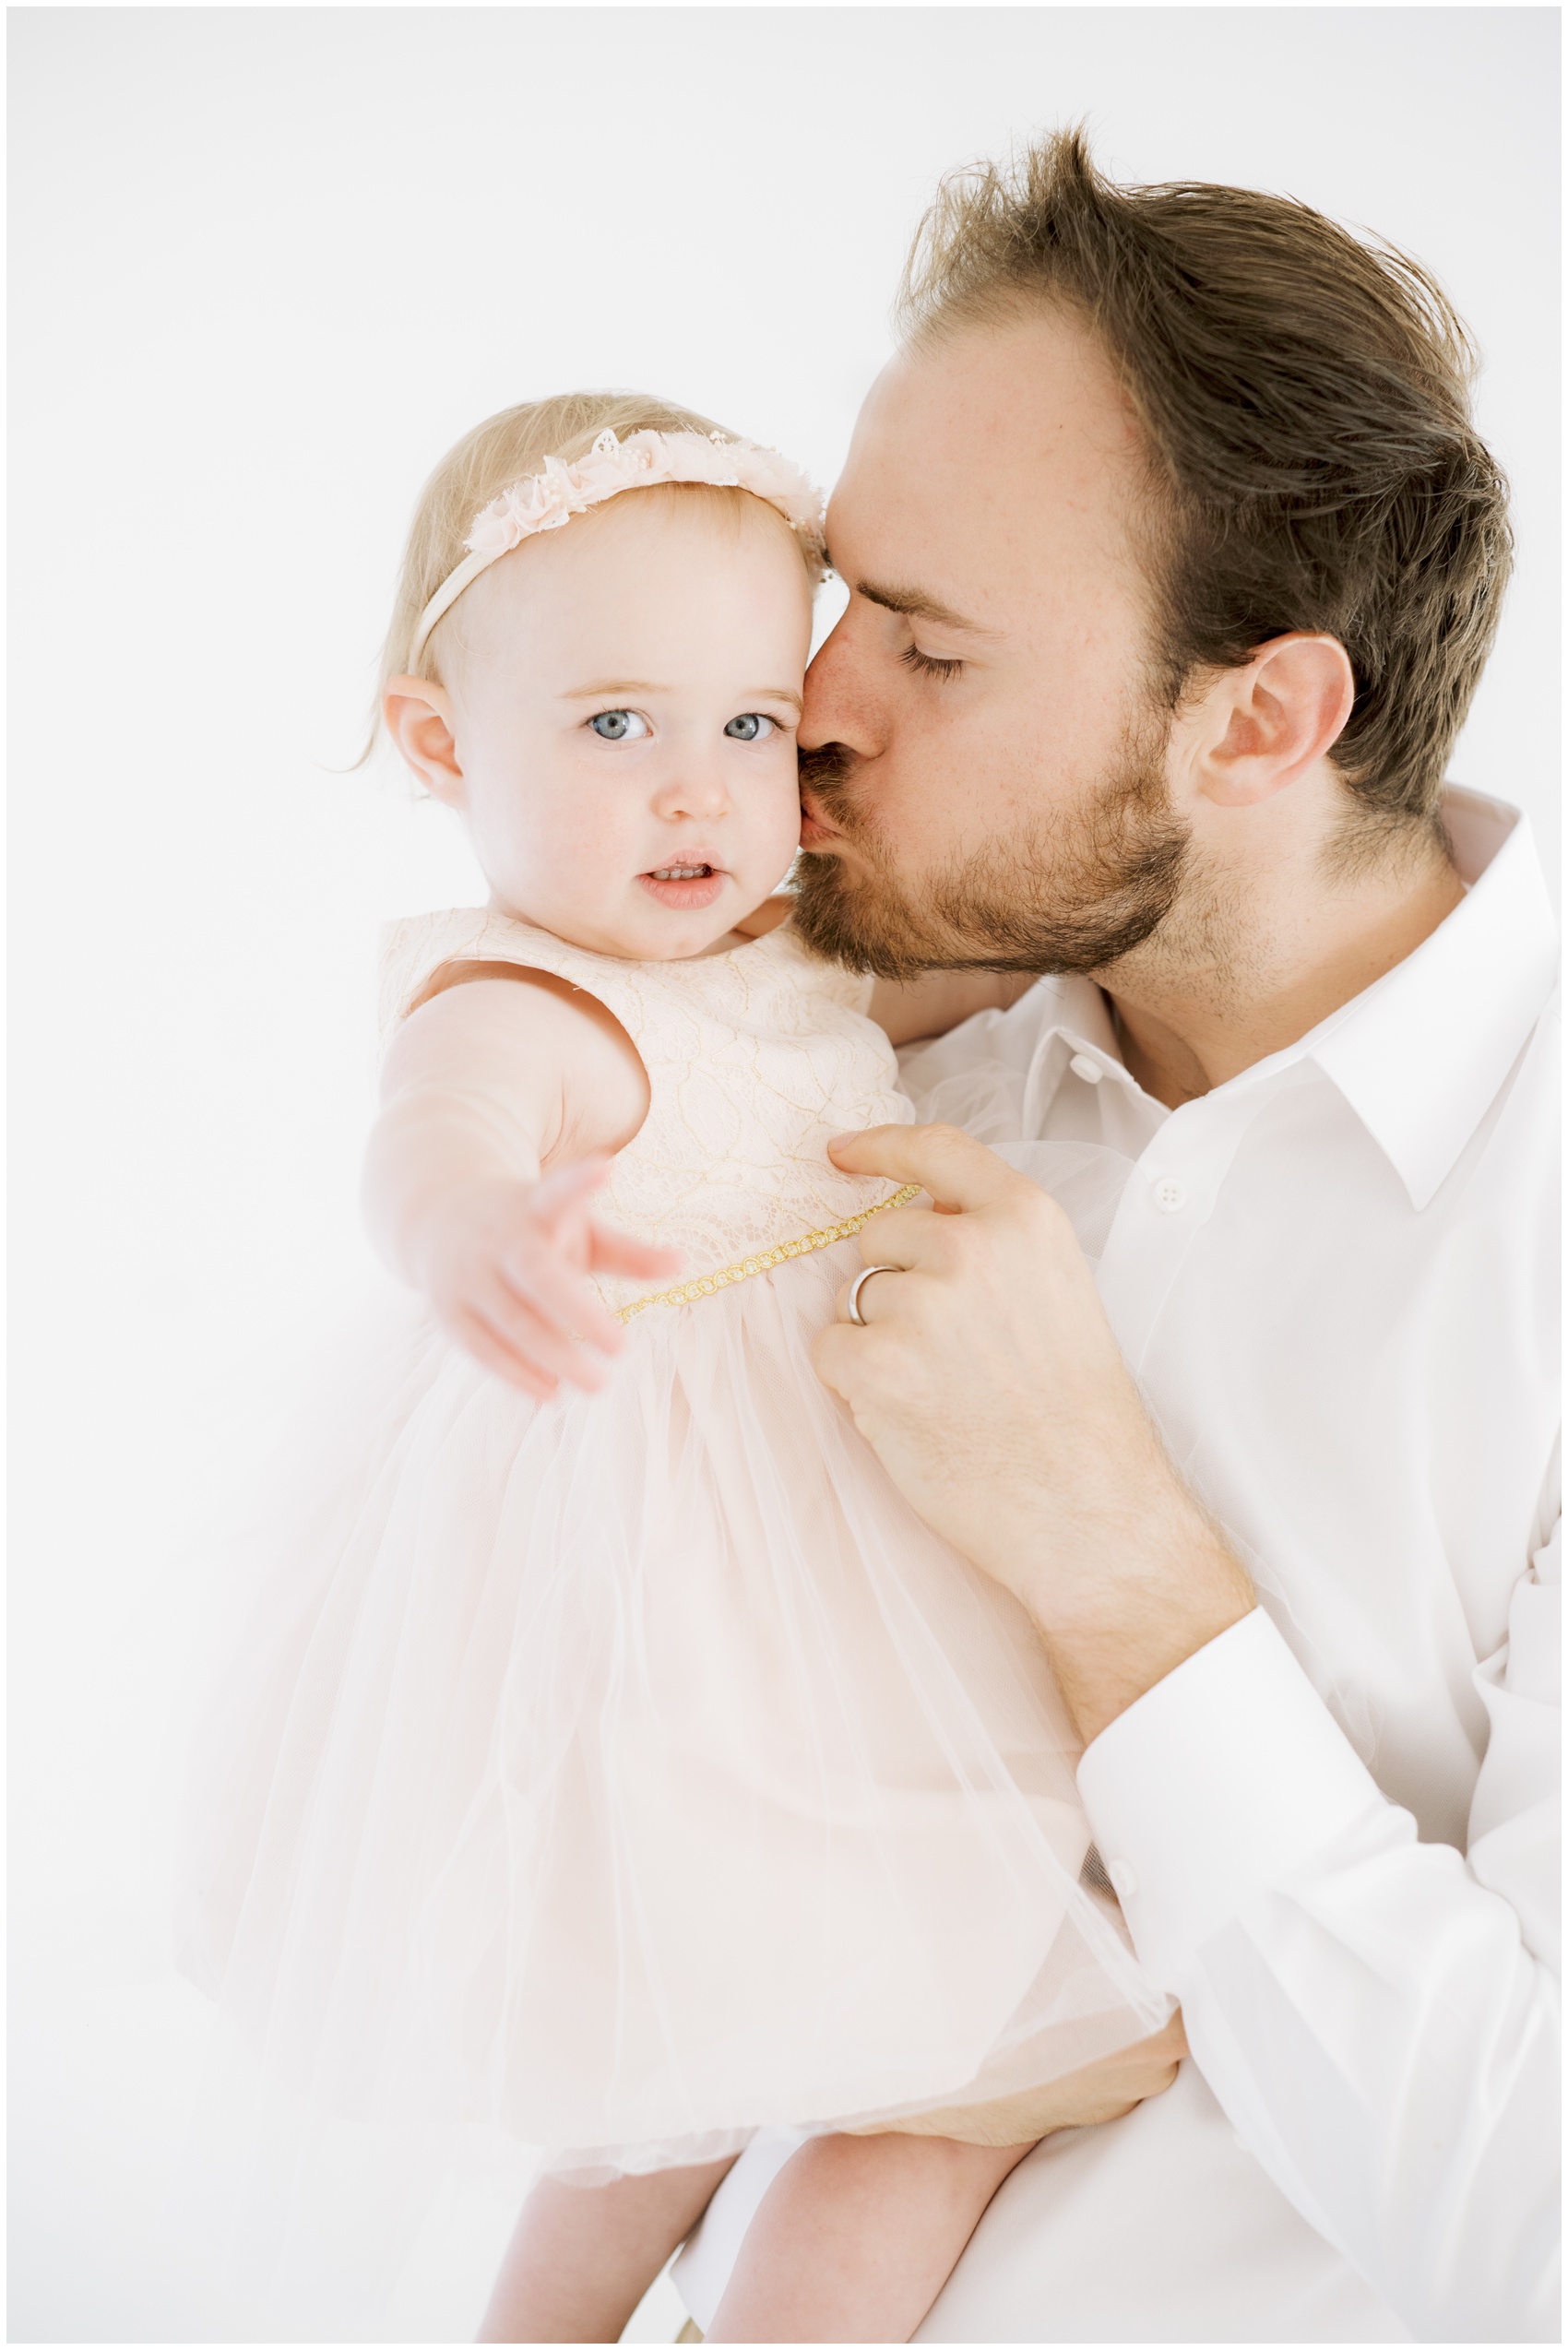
[677,792,1561,2341]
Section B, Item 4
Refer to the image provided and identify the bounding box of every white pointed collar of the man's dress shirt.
[1029,789,1556,1210]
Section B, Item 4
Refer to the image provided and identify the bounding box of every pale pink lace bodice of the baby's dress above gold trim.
[381,908,912,1307]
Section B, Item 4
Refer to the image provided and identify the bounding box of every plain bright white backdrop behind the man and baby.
[12,7,1559,2341]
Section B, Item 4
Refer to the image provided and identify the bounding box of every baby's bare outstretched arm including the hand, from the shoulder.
[364,966,677,1398]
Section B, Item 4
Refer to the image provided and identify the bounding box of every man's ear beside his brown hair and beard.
[1196,632,1357,809]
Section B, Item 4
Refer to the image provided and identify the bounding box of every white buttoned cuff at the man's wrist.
[1079,1608,1387,1990]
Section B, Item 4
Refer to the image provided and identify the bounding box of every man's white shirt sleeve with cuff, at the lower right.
[1079,1523,1561,2343]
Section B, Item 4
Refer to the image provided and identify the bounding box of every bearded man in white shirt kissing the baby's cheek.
[680,136,1561,2341]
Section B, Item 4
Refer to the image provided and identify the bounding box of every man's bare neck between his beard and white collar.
[1100,822,1465,1110]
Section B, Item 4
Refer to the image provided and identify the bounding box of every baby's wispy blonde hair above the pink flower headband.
[364,393,785,756]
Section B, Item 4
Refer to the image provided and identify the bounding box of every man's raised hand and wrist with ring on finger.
[815,1125,1255,1741]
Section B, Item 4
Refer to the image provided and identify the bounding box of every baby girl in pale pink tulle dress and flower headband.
[190,395,1166,2341]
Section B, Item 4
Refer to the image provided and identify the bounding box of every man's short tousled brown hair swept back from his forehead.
[898,129,1512,849]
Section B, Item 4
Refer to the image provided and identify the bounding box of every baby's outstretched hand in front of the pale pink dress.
[411,1158,680,1401]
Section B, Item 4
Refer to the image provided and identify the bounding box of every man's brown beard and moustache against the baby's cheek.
[794,730,1192,980]
